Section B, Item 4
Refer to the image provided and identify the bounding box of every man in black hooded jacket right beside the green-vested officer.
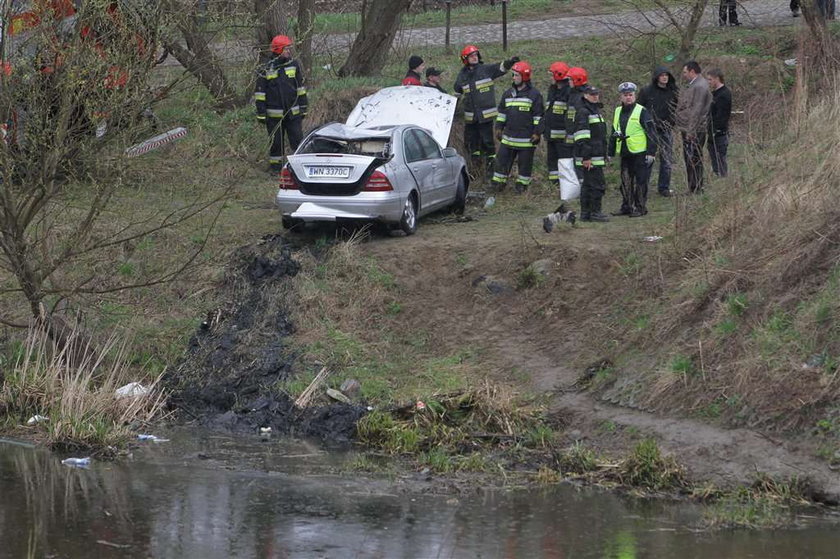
[639,66,679,196]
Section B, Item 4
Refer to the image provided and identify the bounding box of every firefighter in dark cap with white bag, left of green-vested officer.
[574,85,610,222]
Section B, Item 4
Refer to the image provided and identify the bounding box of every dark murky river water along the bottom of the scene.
[0,431,840,559]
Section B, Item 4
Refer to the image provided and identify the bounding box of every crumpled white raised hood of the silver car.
[346,85,457,147]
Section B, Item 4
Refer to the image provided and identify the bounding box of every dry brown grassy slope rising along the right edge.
[624,65,840,428]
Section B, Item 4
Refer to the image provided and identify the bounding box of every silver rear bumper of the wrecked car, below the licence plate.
[276,190,405,223]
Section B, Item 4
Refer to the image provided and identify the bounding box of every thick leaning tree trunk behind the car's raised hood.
[338,0,411,76]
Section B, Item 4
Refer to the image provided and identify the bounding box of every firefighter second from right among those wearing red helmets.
[545,62,577,194]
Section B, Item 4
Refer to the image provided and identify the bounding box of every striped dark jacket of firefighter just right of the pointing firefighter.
[496,82,544,149]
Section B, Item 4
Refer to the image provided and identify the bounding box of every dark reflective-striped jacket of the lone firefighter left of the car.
[254,56,307,120]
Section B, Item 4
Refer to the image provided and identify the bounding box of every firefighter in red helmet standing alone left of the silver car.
[254,35,307,173]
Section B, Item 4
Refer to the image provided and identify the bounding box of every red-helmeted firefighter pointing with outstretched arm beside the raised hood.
[454,45,519,178]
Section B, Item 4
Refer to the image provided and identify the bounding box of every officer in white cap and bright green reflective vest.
[609,82,656,217]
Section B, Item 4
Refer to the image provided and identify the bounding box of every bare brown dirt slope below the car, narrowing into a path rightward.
[364,205,840,502]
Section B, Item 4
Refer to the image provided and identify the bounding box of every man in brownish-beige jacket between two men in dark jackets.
[675,60,712,194]
